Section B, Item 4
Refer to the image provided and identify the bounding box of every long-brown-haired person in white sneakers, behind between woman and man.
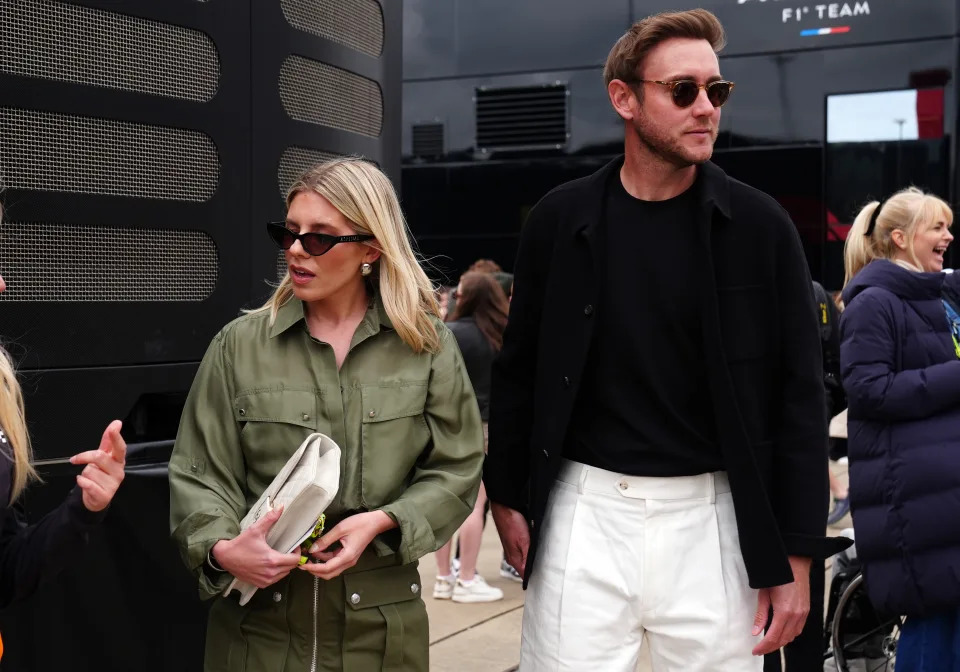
[433,271,508,602]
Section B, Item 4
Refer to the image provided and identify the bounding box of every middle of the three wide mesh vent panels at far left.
[0,108,220,202]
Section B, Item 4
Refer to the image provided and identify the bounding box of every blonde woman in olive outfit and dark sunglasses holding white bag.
[170,159,483,672]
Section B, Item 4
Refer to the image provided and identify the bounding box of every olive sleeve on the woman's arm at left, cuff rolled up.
[170,332,245,597]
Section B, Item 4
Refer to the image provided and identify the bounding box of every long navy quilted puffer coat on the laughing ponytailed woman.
[840,260,960,616]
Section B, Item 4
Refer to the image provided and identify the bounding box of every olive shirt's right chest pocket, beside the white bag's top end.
[360,381,430,509]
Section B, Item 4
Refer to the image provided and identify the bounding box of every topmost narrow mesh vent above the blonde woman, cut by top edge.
[280,0,383,57]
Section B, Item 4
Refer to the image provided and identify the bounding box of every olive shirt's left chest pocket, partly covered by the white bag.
[233,389,329,487]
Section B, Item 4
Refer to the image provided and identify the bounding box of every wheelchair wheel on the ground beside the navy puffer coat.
[830,574,903,672]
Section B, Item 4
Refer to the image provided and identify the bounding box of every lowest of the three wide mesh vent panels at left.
[0,222,217,302]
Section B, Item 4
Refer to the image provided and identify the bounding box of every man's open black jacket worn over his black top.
[484,157,849,588]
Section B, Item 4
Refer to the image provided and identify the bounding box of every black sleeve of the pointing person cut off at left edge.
[0,458,107,608]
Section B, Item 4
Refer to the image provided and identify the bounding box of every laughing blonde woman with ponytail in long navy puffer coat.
[840,188,960,672]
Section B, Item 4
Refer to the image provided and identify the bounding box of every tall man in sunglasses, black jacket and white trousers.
[484,10,844,672]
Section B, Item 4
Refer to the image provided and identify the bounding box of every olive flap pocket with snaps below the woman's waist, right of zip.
[343,564,429,672]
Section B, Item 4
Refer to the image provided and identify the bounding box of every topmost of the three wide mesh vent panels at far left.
[0,0,220,101]
